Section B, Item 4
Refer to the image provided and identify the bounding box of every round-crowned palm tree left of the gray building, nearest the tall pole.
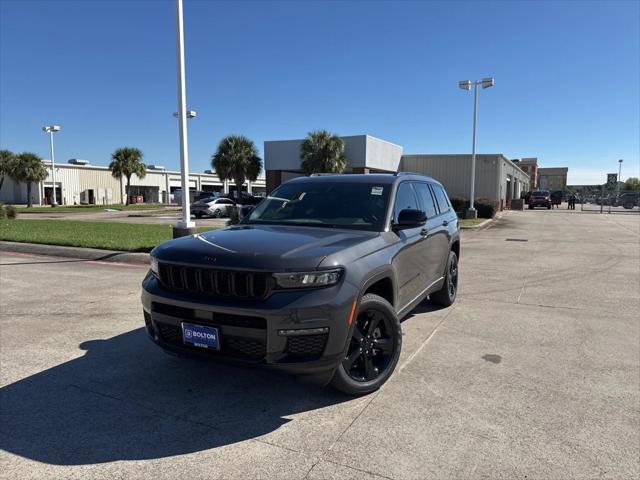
[211,135,262,198]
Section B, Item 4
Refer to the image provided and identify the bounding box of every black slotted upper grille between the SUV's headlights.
[158,262,271,300]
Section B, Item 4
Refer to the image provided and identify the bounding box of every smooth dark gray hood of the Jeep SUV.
[151,225,380,271]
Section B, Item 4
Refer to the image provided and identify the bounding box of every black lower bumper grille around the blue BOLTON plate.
[155,322,267,361]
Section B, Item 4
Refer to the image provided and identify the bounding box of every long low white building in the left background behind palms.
[0,159,265,205]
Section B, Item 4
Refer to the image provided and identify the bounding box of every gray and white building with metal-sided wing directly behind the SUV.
[264,135,530,208]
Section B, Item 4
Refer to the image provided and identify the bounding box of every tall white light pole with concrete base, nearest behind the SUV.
[173,0,197,238]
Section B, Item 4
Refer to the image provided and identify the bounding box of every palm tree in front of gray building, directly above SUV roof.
[300,130,347,175]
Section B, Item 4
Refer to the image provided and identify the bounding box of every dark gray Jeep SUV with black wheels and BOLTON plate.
[142,173,460,395]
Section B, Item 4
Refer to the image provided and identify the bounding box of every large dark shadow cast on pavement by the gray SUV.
[0,328,347,465]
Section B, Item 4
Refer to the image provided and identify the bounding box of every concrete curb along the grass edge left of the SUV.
[0,241,149,265]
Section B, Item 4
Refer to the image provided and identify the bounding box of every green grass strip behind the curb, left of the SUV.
[0,219,214,252]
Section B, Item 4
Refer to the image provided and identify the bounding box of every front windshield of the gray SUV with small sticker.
[245,182,391,231]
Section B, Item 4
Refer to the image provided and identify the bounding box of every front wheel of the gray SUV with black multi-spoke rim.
[331,293,402,396]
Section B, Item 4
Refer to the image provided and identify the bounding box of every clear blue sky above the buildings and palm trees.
[0,0,640,183]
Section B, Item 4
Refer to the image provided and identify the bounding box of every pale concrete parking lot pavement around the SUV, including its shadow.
[0,210,640,479]
